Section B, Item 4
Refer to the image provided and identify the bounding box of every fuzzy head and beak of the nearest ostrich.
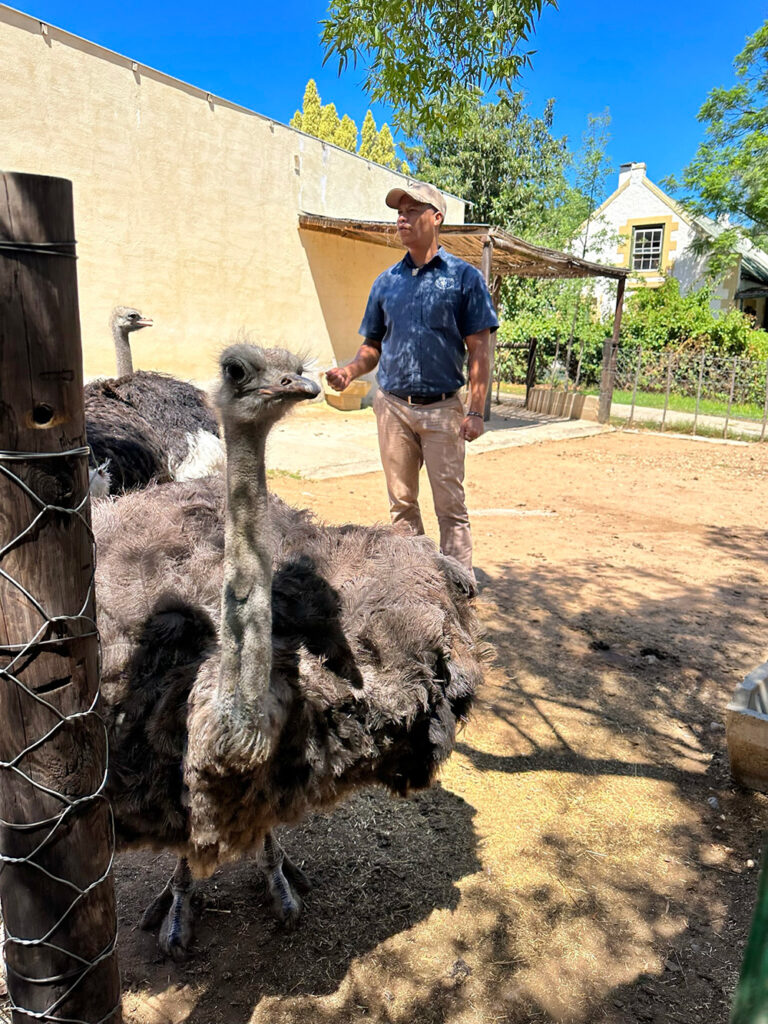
[217,343,319,427]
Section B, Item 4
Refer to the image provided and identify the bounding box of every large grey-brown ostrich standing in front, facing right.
[94,345,486,957]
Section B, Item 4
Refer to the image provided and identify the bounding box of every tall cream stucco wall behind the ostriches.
[0,5,464,380]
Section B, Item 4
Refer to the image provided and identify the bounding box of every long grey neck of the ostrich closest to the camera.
[218,424,272,719]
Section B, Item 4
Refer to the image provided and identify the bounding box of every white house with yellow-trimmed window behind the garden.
[572,164,768,327]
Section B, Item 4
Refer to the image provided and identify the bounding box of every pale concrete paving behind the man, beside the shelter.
[266,402,612,480]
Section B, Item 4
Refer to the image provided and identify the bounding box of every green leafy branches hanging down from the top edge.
[321,0,556,134]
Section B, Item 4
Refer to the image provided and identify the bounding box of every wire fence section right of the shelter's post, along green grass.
[611,346,768,441]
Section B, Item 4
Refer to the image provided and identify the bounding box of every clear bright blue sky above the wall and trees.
[11,0,768,197]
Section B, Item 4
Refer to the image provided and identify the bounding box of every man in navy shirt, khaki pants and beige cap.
[326,182,499,572]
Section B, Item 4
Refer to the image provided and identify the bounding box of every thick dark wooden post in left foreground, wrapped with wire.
[0,174,121,1024]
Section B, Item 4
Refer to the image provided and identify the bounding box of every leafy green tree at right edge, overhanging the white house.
[665,22,768,278]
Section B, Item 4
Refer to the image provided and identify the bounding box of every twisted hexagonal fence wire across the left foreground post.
[0,447,120,1024]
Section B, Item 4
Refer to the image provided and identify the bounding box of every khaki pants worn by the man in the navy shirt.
[374,390,472,571]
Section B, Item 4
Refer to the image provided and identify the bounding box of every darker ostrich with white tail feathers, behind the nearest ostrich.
[84,306,223,494]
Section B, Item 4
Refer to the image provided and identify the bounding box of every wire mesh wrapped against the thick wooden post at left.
[0,447,120,1024]
